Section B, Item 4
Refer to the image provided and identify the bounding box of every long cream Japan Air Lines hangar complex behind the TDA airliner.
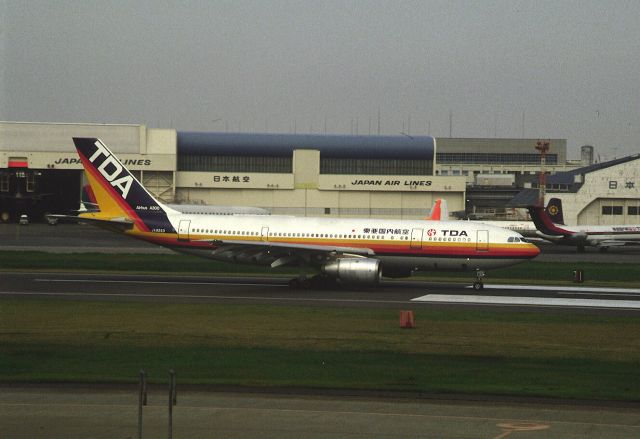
[0,122,628,221]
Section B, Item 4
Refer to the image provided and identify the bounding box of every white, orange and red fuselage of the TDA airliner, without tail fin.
[116,214,539,273]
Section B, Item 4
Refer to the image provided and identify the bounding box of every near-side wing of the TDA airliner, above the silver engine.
[202,239,375,268]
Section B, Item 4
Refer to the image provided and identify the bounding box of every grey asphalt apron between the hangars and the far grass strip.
[0,224,640,263]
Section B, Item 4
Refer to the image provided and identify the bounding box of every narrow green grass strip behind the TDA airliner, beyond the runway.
[0,251,640,284]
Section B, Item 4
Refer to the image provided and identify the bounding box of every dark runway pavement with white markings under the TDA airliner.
[0,272,640,315]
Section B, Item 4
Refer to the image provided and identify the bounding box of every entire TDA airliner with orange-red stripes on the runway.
[51,138,540,289]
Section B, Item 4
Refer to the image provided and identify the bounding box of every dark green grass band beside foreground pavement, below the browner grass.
[2,344,640,401]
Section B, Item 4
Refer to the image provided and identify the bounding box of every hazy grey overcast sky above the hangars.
[0,0,640,158]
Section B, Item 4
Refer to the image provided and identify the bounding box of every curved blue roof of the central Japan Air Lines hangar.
[178,131,435,160]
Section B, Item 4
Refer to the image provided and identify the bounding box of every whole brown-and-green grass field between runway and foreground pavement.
[0,299,640,401]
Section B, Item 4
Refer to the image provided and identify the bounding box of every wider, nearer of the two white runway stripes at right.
[411,294,640,309]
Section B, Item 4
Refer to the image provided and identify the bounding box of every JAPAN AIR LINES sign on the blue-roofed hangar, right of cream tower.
[318,174,466,192]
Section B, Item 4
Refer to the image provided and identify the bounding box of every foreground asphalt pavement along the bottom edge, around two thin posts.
[0,382,640,439]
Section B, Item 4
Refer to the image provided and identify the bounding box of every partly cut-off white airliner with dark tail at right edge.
[528,198,640,252]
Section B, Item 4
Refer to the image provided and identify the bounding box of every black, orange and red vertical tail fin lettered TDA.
[73,137,178,233]
